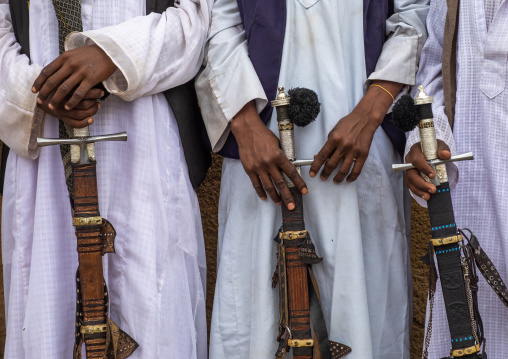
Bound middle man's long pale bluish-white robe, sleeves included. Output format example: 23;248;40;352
197;0;427;359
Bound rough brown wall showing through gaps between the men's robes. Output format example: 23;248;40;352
0;153;430;359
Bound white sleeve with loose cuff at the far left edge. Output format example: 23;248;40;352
0;0;44;159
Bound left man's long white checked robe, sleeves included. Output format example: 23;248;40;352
0;0;212;359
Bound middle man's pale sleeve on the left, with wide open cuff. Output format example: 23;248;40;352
195;0;268;152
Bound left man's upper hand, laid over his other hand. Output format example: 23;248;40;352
32;45;117;110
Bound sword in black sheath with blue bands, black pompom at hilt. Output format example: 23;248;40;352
392;86;508;359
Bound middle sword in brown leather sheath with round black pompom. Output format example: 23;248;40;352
272;87;351;359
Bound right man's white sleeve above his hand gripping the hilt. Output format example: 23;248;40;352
404;1;459;207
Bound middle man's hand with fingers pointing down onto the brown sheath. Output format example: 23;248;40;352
231;102;307;210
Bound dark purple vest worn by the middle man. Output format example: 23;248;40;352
219;0;405;158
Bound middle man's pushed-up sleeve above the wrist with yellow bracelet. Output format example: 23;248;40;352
369;0;429;86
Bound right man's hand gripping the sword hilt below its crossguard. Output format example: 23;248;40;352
406;140;452;201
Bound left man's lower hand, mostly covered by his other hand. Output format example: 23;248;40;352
37;89;104;128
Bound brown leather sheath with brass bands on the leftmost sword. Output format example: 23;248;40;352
72;163;107;358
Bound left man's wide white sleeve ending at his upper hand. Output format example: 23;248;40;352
66;0;213;101
